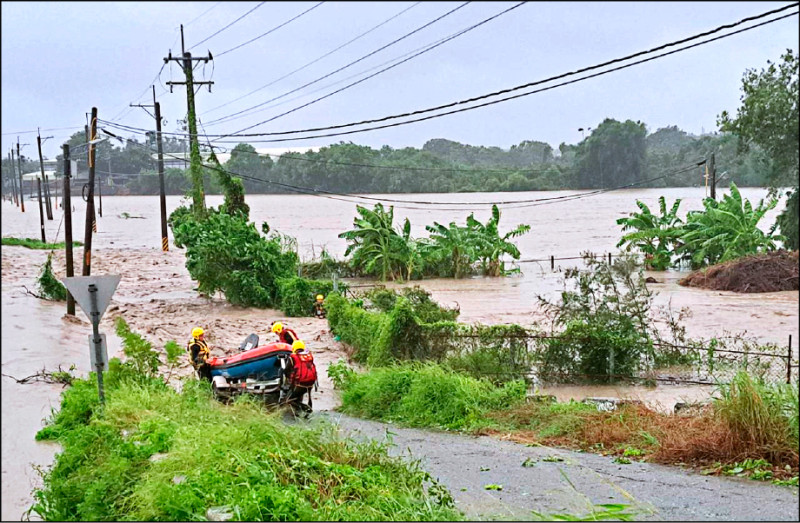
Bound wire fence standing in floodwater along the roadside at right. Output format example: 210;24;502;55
440;327;800;385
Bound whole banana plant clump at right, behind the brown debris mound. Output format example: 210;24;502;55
617;183;786;270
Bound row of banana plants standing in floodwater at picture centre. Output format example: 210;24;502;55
339;203;530;281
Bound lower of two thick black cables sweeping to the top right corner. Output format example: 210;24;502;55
208;7;798;143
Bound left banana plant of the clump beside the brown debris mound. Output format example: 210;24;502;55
617;196;682;271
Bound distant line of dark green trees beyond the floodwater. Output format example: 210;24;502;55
3;119;773;194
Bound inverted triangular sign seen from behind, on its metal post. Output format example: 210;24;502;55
61;274;120;403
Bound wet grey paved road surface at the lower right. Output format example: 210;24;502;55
320;412;800;521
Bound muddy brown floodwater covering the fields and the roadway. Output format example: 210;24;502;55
0;188;798;520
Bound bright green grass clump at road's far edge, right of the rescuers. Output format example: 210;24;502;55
342;363;526;429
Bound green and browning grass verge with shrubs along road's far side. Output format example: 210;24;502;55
328;290;798;485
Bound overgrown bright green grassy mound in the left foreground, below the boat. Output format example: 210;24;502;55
32;370;462;521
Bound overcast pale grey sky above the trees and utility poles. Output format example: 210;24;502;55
2;2;798;157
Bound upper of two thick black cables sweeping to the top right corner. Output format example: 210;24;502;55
211;2;800;137
